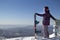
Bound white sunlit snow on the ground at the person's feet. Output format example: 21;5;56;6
0;33;60;40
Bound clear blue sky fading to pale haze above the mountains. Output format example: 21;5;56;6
0;0;60;25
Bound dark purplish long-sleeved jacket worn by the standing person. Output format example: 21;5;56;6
37;13;56;25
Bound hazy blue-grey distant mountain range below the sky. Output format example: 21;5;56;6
0;25;53;38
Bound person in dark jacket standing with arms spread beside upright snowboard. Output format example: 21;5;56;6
35;6;56;38
